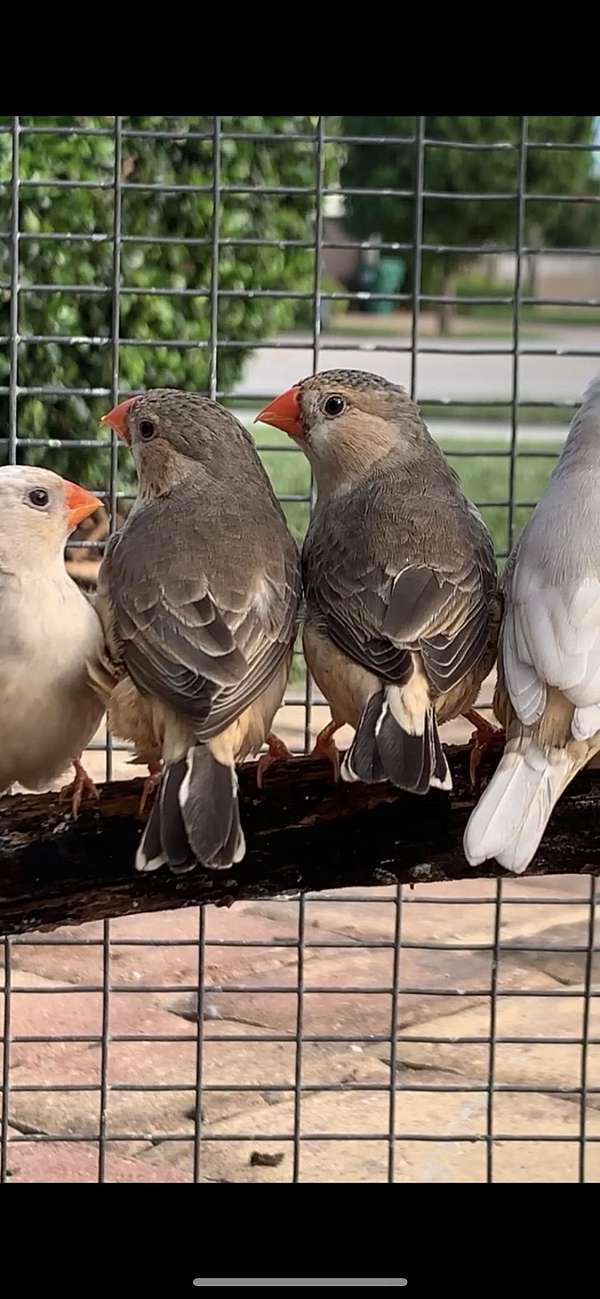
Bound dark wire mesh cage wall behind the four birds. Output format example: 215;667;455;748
0;117;600;1182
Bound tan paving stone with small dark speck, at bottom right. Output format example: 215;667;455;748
142;1070;600;1182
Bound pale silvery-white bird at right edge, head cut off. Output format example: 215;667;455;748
465;375;600;874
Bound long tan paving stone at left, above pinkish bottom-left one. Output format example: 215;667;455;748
9;1025;390;1139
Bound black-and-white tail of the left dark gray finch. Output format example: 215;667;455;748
135;744;245;872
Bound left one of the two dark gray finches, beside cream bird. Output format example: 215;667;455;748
97;390;300;870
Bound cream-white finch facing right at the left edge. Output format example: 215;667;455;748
0;465;104;816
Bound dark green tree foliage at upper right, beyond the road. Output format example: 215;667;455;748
342;116;599;324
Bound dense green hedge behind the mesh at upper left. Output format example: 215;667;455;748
0;117;335;485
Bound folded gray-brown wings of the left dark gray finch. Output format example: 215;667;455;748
103;496;299;739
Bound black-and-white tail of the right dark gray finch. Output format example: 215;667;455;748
342;683;452;794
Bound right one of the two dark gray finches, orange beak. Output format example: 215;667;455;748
257;370;499;794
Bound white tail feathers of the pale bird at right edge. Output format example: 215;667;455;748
464;738;579;876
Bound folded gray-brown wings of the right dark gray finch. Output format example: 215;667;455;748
305;491;496;694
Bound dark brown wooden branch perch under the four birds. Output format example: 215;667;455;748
0;748;600;934
